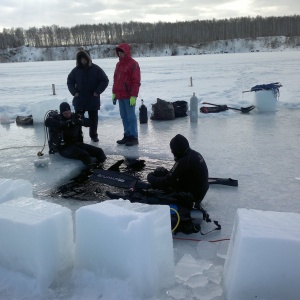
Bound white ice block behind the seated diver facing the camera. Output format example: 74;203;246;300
30;98;67;123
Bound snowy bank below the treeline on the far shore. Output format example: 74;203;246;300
0;36;300;62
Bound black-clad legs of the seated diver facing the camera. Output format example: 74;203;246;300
59;143;106;165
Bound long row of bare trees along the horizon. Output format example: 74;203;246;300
0;15;300;49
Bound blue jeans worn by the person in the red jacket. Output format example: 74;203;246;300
118;99;138;138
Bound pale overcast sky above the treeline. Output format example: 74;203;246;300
0;0;300;31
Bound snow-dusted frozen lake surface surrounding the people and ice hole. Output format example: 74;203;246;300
0;51;300;300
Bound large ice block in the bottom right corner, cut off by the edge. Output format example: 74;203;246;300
224;209;300;300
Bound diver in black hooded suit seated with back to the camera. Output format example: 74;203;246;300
147;134;209;208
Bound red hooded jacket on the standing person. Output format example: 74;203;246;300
112;43;141;99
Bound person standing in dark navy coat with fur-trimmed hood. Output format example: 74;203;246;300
67;50;109;142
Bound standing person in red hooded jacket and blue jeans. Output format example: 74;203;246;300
112;43;141;146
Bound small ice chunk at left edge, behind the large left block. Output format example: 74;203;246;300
0;178;32;203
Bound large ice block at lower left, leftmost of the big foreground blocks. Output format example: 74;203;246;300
0;197;74;288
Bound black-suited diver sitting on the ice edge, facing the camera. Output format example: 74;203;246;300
45;102;106;166
